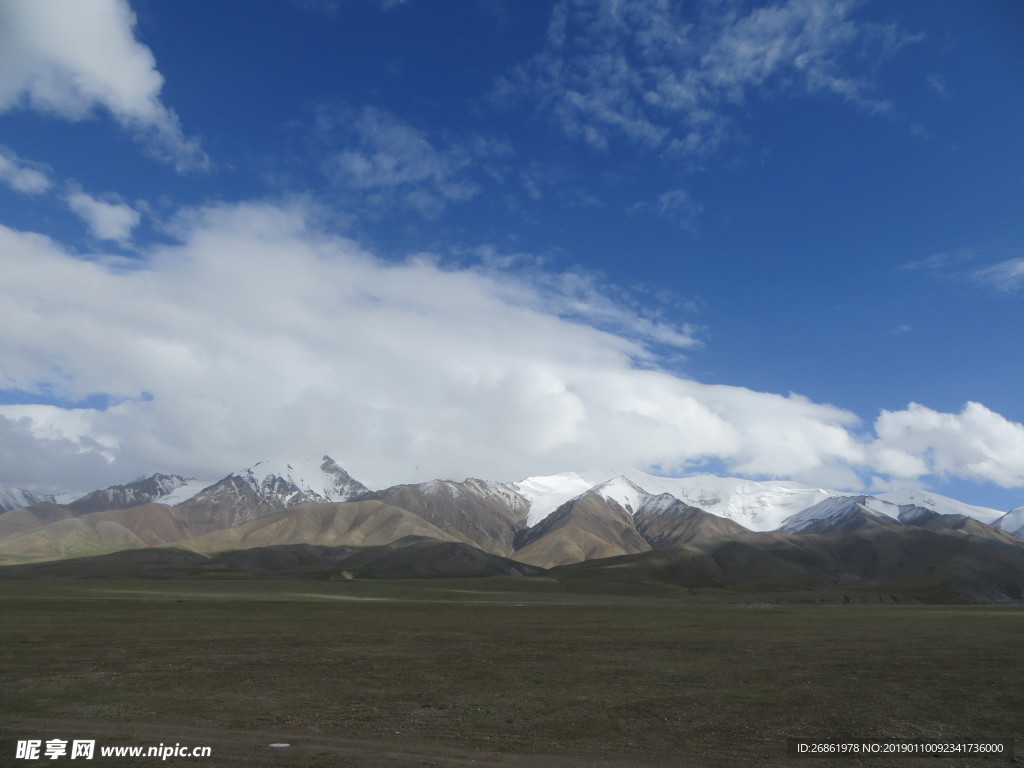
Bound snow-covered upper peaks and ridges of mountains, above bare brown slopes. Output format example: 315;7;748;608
0;456;1011;540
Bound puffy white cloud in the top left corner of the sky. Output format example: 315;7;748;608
0;0;208;169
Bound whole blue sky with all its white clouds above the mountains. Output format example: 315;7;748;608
0;0;1024;509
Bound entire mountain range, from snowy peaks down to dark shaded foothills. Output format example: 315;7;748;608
0;456;1024;602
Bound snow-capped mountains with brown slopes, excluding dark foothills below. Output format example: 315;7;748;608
0;456;1024;567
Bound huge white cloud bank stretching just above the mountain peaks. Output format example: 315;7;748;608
0;204;1024;495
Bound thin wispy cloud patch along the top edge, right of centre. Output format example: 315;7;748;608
498;0;913;156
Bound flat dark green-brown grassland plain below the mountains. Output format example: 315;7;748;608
0;579;1024;768
